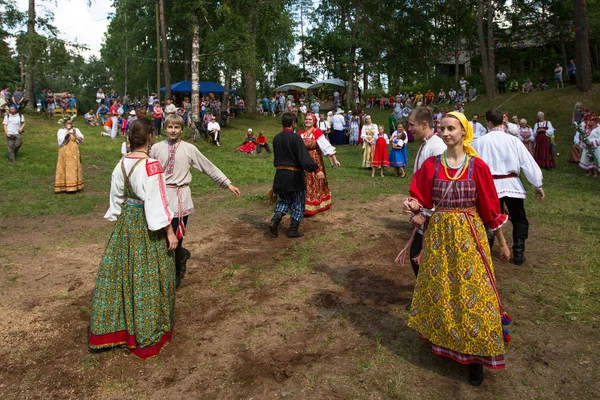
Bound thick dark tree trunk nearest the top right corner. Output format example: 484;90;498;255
574;0;592;92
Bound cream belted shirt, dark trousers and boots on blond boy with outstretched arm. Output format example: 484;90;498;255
150;139;231;286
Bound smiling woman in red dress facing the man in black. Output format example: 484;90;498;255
298;114;340;216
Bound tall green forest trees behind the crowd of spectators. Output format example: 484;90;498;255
0;0;600;115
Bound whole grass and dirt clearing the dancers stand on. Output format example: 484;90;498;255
0;86;600;399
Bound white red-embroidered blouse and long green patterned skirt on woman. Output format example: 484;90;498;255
89;157;175;358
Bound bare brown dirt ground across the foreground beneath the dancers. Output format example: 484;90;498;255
0;187;600;399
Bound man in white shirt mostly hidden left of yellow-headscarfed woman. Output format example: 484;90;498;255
396;107;446;310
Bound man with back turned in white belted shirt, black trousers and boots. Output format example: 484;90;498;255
474;110;546;265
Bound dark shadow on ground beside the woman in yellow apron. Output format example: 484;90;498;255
311;264;466;381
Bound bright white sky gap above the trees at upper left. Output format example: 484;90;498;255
16;0;114;58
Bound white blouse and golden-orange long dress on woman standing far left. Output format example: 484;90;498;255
54;128;85;193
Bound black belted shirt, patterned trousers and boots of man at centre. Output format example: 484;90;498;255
269;128;322;237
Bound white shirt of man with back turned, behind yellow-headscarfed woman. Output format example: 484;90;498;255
473;131;543;199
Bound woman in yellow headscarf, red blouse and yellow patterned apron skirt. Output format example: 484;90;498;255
401;112;510;386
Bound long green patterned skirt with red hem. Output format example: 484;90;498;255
89;200;175;358
